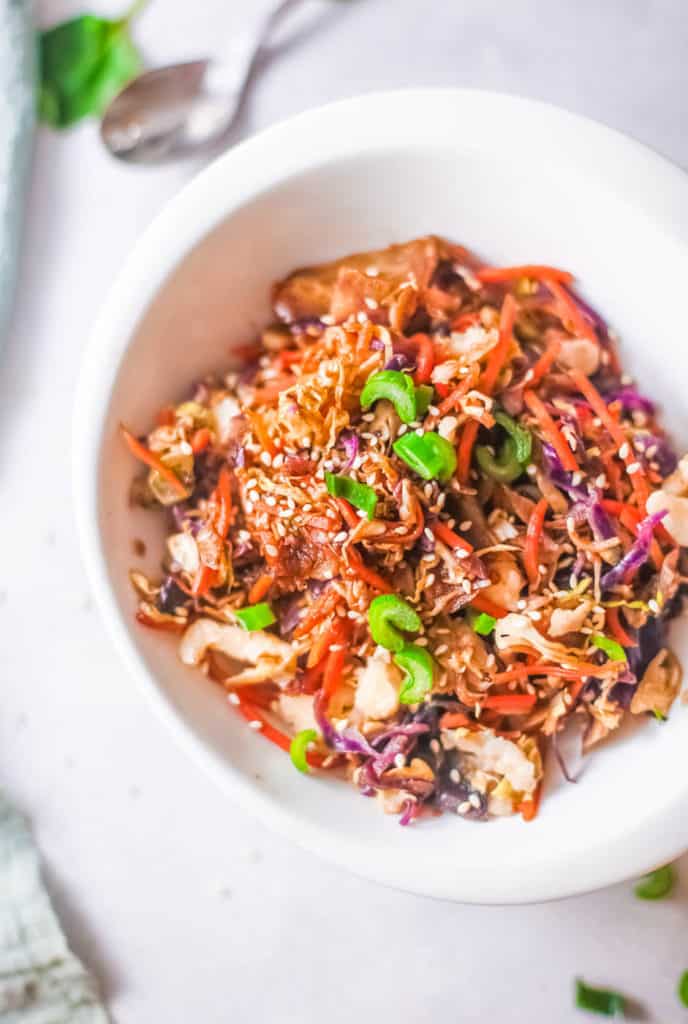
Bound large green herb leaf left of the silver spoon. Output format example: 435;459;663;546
38;11;142;128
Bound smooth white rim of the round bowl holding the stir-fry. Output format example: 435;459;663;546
72;88;688;904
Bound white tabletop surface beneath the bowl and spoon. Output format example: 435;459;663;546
0;0;688;1024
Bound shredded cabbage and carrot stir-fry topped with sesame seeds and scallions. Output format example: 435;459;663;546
123;237;688;824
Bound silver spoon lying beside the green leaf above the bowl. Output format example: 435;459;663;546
100;0;299;164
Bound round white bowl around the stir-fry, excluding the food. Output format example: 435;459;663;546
75;90;688;903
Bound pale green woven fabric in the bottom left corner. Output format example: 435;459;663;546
0;793;108;1024
